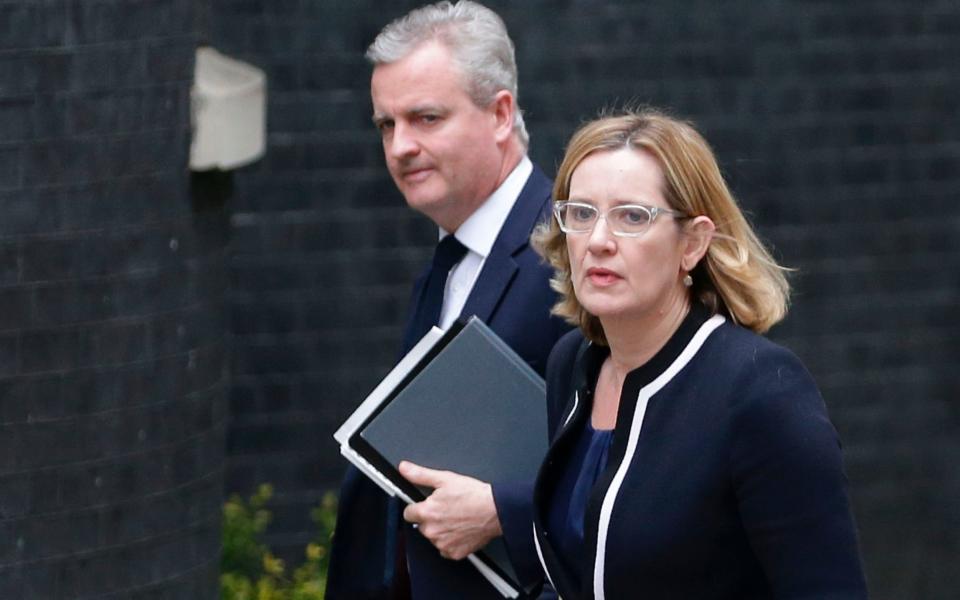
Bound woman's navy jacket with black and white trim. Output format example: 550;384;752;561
534;305;867;600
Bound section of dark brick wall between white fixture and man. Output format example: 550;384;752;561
209;1;431;559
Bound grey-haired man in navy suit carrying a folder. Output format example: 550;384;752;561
327;0;567;600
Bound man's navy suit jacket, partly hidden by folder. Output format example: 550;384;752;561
326;166;569;600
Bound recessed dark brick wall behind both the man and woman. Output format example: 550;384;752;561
210;0;960;599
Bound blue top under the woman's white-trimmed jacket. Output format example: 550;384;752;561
547;418;613;584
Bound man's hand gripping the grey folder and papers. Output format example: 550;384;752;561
400;461;503;560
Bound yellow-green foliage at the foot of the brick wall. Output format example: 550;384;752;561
220;484;337;600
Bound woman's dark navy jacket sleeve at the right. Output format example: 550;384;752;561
729;347;867;600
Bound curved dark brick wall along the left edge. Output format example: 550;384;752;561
0;0;228;600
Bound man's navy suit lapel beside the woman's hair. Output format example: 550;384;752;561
460;165;551;323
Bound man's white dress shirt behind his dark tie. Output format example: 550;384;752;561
439;156;533;330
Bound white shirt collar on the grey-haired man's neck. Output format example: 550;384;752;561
440;156;533;258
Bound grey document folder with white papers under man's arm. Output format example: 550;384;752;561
334;317;547;597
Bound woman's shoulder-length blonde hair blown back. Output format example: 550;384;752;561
532;108;790;344
